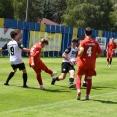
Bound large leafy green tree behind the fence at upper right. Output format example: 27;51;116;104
62;0;113;30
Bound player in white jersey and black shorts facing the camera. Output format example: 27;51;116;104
51;38;78;88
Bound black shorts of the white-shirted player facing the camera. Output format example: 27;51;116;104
61;62;75;73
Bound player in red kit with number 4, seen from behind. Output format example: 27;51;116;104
76;27;102;100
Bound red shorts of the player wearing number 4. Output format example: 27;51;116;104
77;67;96;76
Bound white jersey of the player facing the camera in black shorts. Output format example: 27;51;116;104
63;46;78;62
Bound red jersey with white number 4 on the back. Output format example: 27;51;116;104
78;38;102;69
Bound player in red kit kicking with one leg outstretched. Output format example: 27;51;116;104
29;38;57;90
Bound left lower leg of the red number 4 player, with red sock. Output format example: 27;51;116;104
76;75;82;100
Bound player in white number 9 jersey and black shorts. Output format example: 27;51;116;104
0;31;30;88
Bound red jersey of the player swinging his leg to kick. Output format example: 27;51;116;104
29;43;42;65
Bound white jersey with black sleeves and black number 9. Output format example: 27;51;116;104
2;40;23;65
